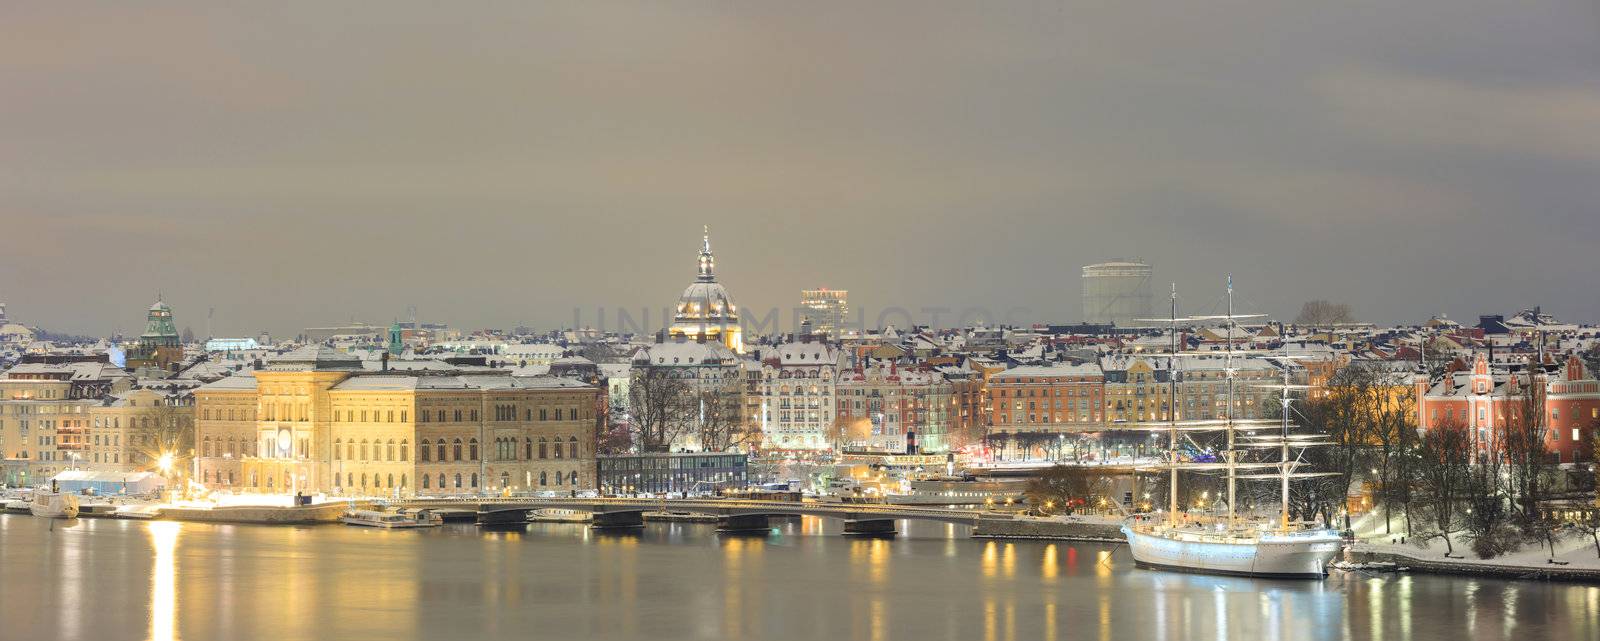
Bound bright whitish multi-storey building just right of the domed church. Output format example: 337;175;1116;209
760;337;840;451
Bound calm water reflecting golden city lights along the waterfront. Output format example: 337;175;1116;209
0;515;1600;641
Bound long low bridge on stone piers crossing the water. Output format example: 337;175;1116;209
408;497;1011;535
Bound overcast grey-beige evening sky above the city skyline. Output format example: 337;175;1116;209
0;0;1600;336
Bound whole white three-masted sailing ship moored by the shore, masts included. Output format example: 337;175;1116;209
1122;277;1342;579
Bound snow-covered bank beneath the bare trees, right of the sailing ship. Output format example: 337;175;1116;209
1350;510;1600;571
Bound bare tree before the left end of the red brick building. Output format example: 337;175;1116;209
1416;420;1472;556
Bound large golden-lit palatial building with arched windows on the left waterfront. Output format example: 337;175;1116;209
195;345;602;496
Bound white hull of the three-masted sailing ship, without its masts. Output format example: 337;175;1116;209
1122;526;1342;579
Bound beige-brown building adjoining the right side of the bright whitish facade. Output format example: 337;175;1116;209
835;361;955;454
